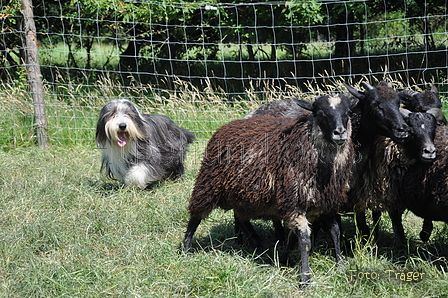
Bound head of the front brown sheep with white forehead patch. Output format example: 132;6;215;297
294;95;358;145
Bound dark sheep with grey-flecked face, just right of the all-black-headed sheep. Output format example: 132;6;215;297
358;109;436;245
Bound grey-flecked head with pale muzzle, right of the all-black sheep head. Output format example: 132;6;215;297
400;109;437;162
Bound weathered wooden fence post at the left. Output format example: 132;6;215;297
22;0;48;148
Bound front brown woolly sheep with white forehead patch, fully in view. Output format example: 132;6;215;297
183;95;356;283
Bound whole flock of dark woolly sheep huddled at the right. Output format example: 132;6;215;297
183;82;448;283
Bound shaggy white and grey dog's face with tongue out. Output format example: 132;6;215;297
96;99;144;147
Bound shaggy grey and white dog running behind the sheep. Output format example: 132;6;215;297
96;99;195;189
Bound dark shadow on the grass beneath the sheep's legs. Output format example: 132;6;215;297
183;217;448;272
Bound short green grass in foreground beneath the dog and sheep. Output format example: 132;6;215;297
0;143;448;297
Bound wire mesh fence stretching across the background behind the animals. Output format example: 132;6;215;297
0;0;448;148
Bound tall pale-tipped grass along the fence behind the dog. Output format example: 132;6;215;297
0;74;309;150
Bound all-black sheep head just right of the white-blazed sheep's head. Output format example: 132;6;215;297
344;82;409;143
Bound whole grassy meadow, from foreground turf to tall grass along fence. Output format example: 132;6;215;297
0;76;448;297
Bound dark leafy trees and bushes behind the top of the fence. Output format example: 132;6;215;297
0;0;445;88
